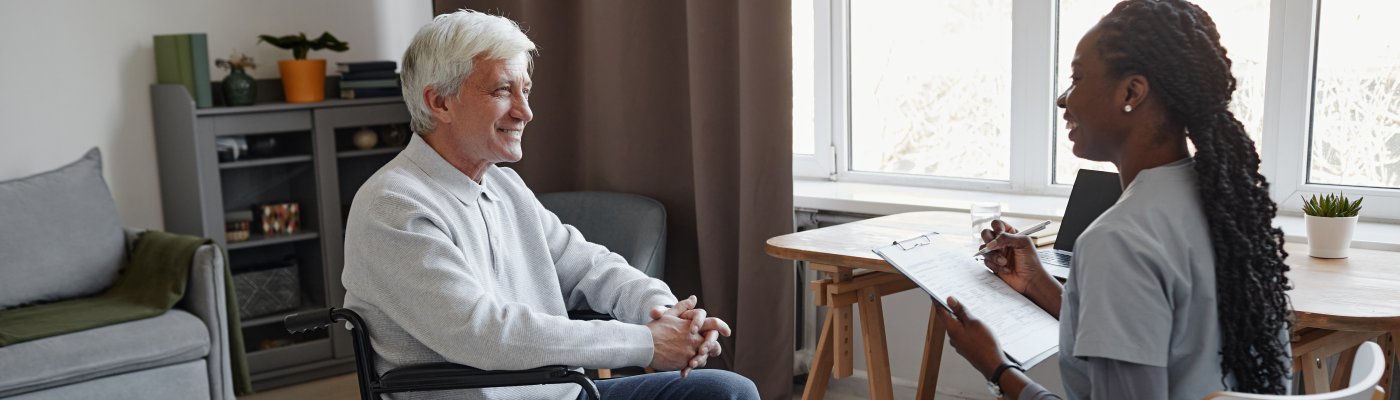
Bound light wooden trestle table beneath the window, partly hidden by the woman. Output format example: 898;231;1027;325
767;211;1400;399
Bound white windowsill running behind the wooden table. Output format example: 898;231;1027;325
792;178;1400;252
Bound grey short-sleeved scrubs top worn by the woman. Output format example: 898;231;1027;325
1022;158;1287;400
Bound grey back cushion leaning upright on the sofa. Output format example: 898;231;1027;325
0;147;125;309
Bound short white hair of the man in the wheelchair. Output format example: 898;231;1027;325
402;10;535;134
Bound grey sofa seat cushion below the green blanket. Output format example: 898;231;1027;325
0;309;209;397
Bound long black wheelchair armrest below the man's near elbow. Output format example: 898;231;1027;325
379;362;598;399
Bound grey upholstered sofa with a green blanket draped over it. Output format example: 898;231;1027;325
0;148;234;399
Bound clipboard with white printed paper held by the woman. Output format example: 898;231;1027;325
872;232;1060;368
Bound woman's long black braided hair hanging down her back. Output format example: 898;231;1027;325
1098;0;1291;394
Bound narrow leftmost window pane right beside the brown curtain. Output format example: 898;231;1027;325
792;0;816;154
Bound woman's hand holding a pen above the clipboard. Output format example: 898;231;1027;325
981;220;1064;319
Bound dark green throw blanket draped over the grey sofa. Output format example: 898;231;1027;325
0;231;252;394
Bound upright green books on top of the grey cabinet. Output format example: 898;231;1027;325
155;34;214;108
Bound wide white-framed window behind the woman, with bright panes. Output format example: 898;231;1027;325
792;0;1400;220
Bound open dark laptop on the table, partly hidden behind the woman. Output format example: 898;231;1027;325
1037;169;1123;280
